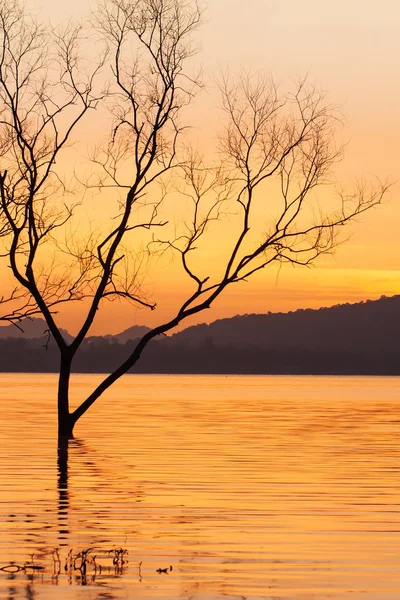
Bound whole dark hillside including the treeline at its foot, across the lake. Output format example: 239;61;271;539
0;296;400;375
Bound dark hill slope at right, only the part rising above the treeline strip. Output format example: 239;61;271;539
171;295;400;351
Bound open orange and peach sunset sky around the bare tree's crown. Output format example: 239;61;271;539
3;0;400;333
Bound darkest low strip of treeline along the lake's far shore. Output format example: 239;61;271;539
0;339;400;375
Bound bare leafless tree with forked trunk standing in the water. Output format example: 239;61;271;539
0;0;386;436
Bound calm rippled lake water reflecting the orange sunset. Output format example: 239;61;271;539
0;374;400;600
